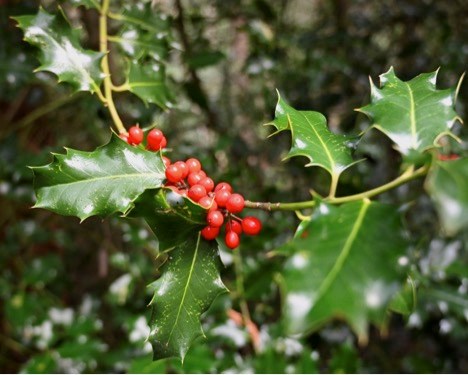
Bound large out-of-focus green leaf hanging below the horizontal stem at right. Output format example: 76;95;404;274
278;200;406;341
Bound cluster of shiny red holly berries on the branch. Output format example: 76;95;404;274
120;126;262;249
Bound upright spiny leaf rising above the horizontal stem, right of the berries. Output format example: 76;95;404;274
266;93;356;179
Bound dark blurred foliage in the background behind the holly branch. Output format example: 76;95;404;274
0;0;468;373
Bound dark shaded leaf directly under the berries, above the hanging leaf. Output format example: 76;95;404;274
135;188;207;251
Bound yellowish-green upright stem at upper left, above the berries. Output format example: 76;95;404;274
99;0;127;133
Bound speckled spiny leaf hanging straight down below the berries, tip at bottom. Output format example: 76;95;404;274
149;234;227;361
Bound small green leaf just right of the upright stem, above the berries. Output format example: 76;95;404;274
127;61;172;109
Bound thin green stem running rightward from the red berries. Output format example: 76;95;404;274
245;166;429;211
